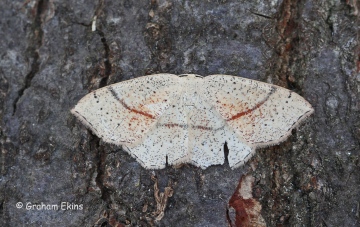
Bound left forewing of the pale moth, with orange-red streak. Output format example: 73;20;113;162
71;74;179;145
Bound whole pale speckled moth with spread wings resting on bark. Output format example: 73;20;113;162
71;74;313;169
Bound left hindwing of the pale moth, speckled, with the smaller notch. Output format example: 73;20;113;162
127;94;189;169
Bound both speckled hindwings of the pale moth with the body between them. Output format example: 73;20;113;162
127;80;254;169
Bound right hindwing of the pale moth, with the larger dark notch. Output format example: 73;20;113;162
187;91;254;169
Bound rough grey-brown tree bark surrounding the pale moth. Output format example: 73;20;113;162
0;0;360;226
